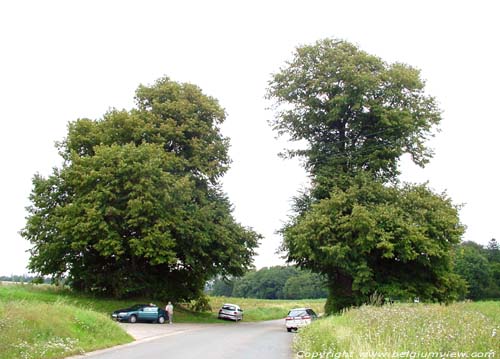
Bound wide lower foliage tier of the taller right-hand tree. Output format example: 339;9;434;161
283;178;463;312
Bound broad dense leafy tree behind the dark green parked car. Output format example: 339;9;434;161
22;78;259;300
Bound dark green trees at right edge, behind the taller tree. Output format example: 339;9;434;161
454;239;500;300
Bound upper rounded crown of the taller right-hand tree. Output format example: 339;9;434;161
268;39;441;186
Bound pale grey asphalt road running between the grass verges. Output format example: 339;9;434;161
72;320;294;359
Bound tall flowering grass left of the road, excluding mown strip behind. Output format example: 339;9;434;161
0;299;132;359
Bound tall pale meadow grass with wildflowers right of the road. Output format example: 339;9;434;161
294;302;500;358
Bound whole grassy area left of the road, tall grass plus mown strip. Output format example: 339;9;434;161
0;284;137;359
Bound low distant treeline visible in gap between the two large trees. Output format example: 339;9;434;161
208;266;327;299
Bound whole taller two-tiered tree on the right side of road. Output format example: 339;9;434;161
268;39;463;311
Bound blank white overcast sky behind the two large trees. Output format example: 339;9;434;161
0;0;500;275
